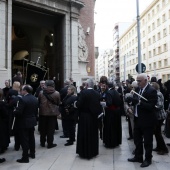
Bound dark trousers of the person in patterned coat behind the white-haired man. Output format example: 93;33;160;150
155;120;168;151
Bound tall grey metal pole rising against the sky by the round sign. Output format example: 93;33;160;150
136;0;142;74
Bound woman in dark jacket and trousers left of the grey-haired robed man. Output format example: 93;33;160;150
60;85;78;146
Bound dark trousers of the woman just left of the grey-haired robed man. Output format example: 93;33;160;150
65;119;76;142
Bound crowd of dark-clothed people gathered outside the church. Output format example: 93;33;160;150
0;73;170;167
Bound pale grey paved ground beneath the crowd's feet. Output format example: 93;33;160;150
0;117;170;170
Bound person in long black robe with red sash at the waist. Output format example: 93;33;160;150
103;83;122;148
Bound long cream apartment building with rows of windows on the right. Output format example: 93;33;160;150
119;0;170;82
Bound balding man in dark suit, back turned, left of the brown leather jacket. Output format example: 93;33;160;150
14;85;38;163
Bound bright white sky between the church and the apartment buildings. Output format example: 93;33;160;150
94;0;154;51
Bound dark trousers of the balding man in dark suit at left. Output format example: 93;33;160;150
19;127;35;159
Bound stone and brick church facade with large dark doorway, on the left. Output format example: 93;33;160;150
0;0;95;88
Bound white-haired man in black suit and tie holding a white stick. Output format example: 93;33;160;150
128;73;157;167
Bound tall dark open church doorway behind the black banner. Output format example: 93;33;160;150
12;3;65;89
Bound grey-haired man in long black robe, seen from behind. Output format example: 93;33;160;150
74;79;102;159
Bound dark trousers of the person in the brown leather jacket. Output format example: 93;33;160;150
39;116;56;145
